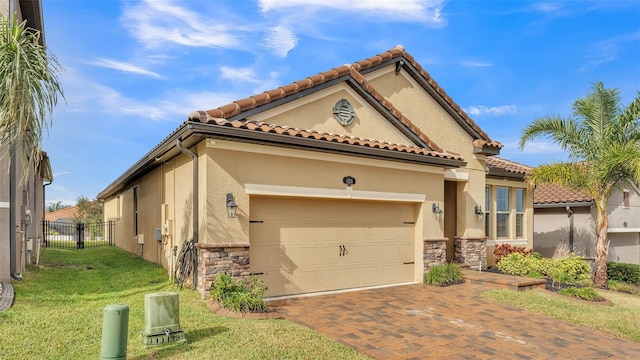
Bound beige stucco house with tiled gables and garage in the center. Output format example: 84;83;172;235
97;46;533;296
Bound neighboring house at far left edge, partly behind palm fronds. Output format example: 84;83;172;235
0;0;53;282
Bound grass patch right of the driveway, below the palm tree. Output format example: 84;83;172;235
481;290;640;343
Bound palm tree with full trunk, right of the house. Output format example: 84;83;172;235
520;82;640;287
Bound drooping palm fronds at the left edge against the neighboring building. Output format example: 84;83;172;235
0;18;64;180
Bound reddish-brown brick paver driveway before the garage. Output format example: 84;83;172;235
270;284;640;359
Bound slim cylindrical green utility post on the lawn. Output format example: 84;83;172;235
100;304;129;360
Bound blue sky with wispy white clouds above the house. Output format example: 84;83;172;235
43;0;640;205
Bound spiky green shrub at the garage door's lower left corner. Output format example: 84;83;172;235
211;273;267;312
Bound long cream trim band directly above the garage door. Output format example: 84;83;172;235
244;184;427;203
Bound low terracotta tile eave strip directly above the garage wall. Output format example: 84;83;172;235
189;111;462;161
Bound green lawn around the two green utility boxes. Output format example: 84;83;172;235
0;247;367;360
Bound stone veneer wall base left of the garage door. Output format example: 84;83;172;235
196;243;249;299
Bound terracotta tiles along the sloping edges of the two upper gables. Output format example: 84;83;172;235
189;46;502;152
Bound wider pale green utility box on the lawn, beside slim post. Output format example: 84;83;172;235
140;292;187;347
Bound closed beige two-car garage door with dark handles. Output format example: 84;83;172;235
249;197;416;296
